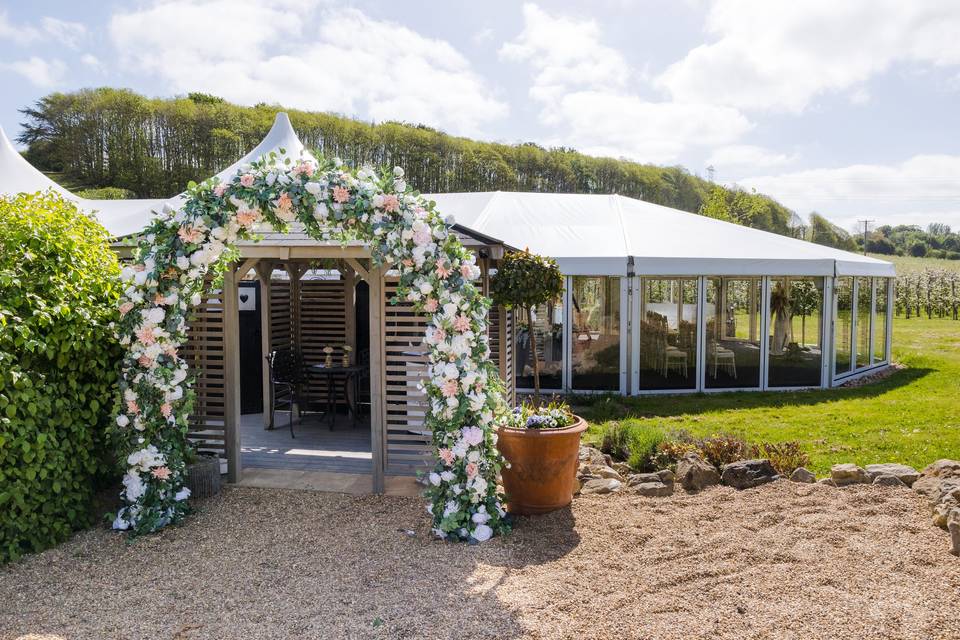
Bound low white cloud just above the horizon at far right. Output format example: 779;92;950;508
740;155;960;228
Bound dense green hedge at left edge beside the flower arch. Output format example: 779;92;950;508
0;193;120;562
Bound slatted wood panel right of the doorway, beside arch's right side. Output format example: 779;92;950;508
380;276;433;473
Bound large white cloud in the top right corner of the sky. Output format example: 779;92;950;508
658;0;960;112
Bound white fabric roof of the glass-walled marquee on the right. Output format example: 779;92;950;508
428;191;895;276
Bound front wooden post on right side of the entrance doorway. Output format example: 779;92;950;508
368;267;386;493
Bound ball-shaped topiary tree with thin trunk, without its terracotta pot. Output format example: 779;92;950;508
490;251;563;402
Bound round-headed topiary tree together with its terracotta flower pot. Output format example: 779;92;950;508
491;251;587;514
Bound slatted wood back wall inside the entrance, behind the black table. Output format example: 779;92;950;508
297;276;356;406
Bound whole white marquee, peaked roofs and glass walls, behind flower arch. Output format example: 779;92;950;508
0;113;895;393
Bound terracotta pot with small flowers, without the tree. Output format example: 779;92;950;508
497;402;587;515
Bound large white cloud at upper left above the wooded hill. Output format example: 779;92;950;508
110;0;507;135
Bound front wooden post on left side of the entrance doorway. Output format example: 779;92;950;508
221;264;243;482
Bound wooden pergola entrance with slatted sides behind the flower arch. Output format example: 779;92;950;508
176;227;515;493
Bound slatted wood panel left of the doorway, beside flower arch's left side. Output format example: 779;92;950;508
181;284;226;457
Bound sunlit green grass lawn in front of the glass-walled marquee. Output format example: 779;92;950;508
575;318;960;474
